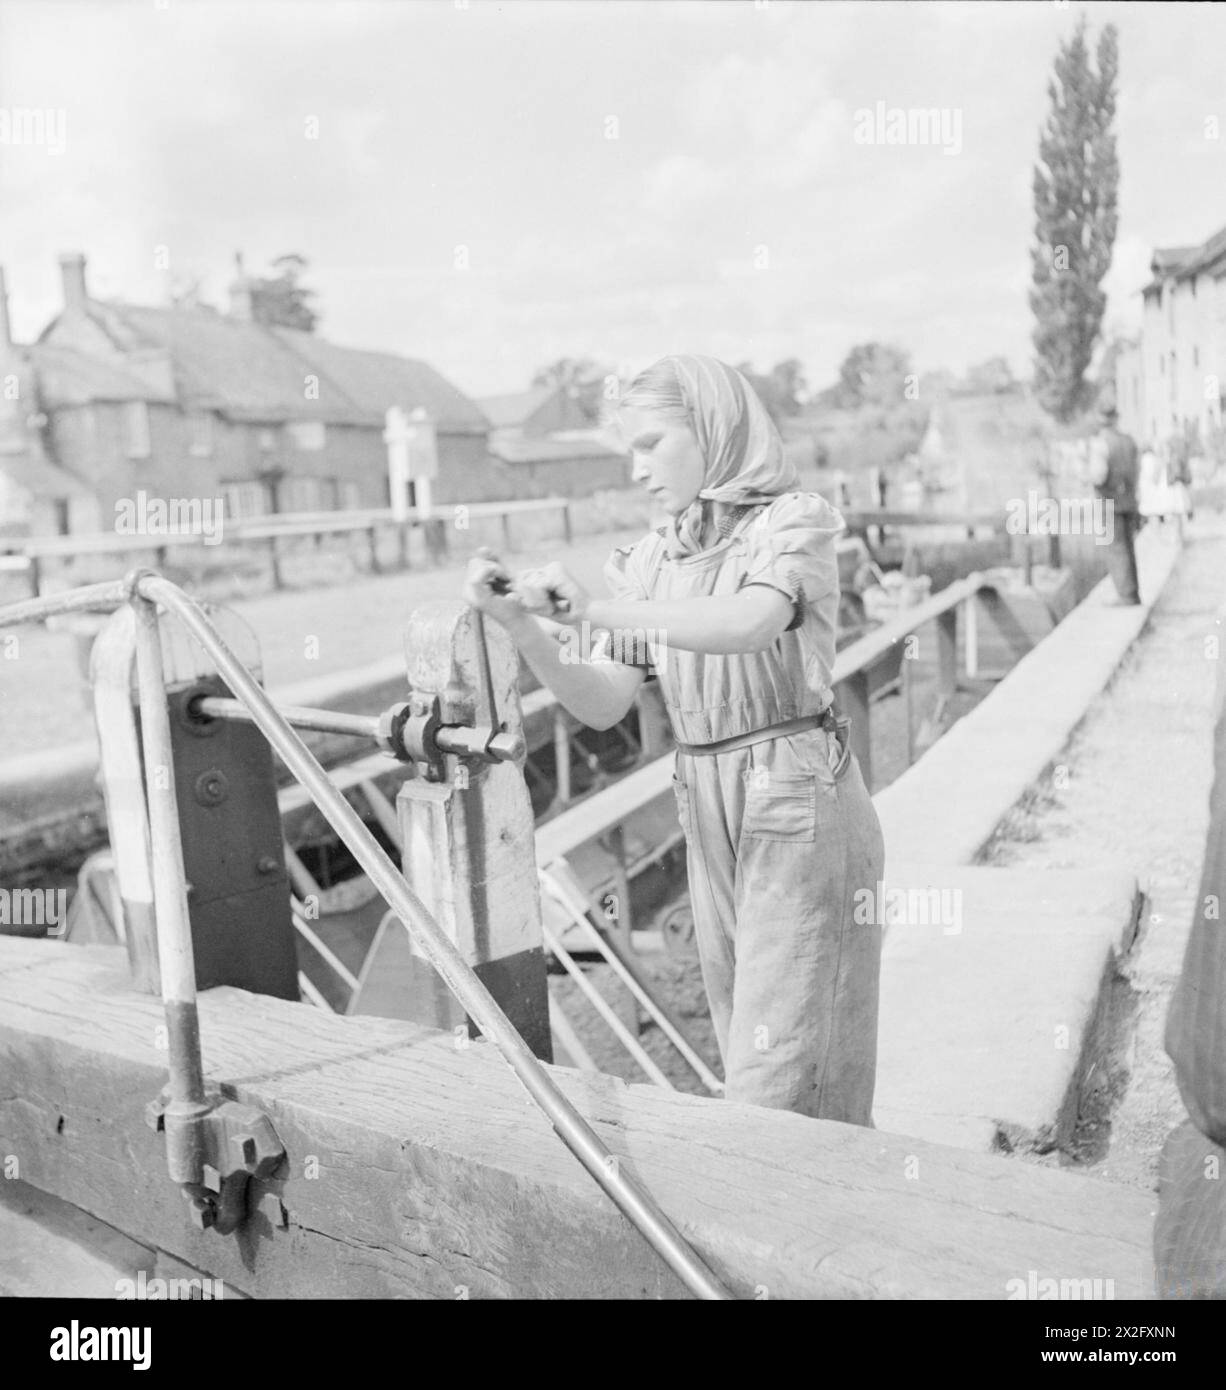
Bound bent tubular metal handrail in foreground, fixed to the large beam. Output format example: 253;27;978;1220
0;570;731;1300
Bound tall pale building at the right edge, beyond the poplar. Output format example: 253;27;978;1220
1115;227;1226;453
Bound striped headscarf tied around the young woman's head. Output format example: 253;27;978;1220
653;353;801;559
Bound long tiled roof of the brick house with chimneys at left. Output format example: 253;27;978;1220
32;300;488;434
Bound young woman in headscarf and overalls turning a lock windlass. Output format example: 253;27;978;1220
466;356;883;1125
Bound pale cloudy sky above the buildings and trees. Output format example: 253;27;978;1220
0;0;1226;395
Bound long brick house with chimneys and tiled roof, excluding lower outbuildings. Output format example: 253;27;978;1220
0;254;505;530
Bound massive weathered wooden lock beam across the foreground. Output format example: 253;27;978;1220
0;938;1151;1298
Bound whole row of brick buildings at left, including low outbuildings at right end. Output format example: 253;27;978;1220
0;253;630;537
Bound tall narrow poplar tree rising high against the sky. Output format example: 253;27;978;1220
1030;15;1119;423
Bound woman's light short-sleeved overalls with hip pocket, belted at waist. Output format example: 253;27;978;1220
606;493;884;1125
